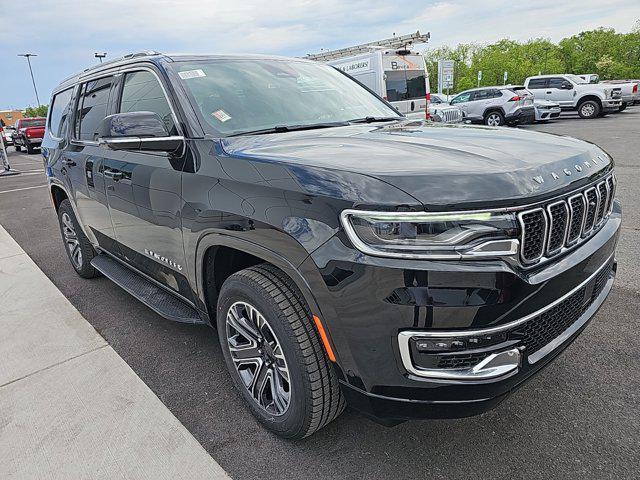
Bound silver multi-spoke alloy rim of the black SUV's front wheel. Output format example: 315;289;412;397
226;302;291;415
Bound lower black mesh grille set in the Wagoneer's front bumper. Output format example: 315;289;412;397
509;263;611;355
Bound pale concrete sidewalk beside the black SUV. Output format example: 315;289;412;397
0;226;229;480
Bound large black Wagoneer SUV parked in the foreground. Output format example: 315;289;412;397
43;53;621;438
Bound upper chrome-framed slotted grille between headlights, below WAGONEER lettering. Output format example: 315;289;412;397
518;174;616;265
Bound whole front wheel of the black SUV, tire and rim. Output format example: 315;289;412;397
216;264;345;439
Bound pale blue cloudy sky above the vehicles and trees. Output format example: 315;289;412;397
0;0;640;109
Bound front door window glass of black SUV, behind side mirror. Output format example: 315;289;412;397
120;71;177;135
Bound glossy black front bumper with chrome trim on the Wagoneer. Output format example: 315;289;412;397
307;203;621;422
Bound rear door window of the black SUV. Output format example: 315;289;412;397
76;77;112;140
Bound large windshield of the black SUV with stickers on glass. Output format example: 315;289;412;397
173;59;402;135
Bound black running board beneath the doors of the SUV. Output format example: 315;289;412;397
91;254;204;323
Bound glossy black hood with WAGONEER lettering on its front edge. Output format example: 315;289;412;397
222;122;612;209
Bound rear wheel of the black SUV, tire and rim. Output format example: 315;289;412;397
58;199;99;278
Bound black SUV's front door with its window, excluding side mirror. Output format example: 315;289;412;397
102;66;189;296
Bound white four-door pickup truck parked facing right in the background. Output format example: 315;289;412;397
524;74;622;118
